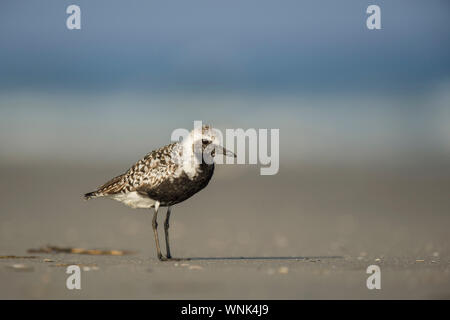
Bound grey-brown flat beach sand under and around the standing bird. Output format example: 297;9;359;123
0;165;450;299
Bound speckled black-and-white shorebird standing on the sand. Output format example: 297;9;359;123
84;125;236;261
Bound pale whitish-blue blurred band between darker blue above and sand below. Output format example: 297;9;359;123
0;83;450;168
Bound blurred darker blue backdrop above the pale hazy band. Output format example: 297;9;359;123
0;0;450;91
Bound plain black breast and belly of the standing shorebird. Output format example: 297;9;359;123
145;164;214;206
